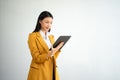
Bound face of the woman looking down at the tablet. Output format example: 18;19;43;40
40;17;53;33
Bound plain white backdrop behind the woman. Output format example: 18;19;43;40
0;0;120;80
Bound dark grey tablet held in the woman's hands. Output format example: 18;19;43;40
50;36;71;50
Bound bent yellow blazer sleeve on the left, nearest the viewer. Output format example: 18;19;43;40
28;33;47;63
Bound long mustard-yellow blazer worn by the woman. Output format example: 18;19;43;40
27;32;60;80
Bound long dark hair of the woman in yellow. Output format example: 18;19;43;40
33;11;53;32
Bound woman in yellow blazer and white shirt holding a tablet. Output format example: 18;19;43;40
27;11;64;80
